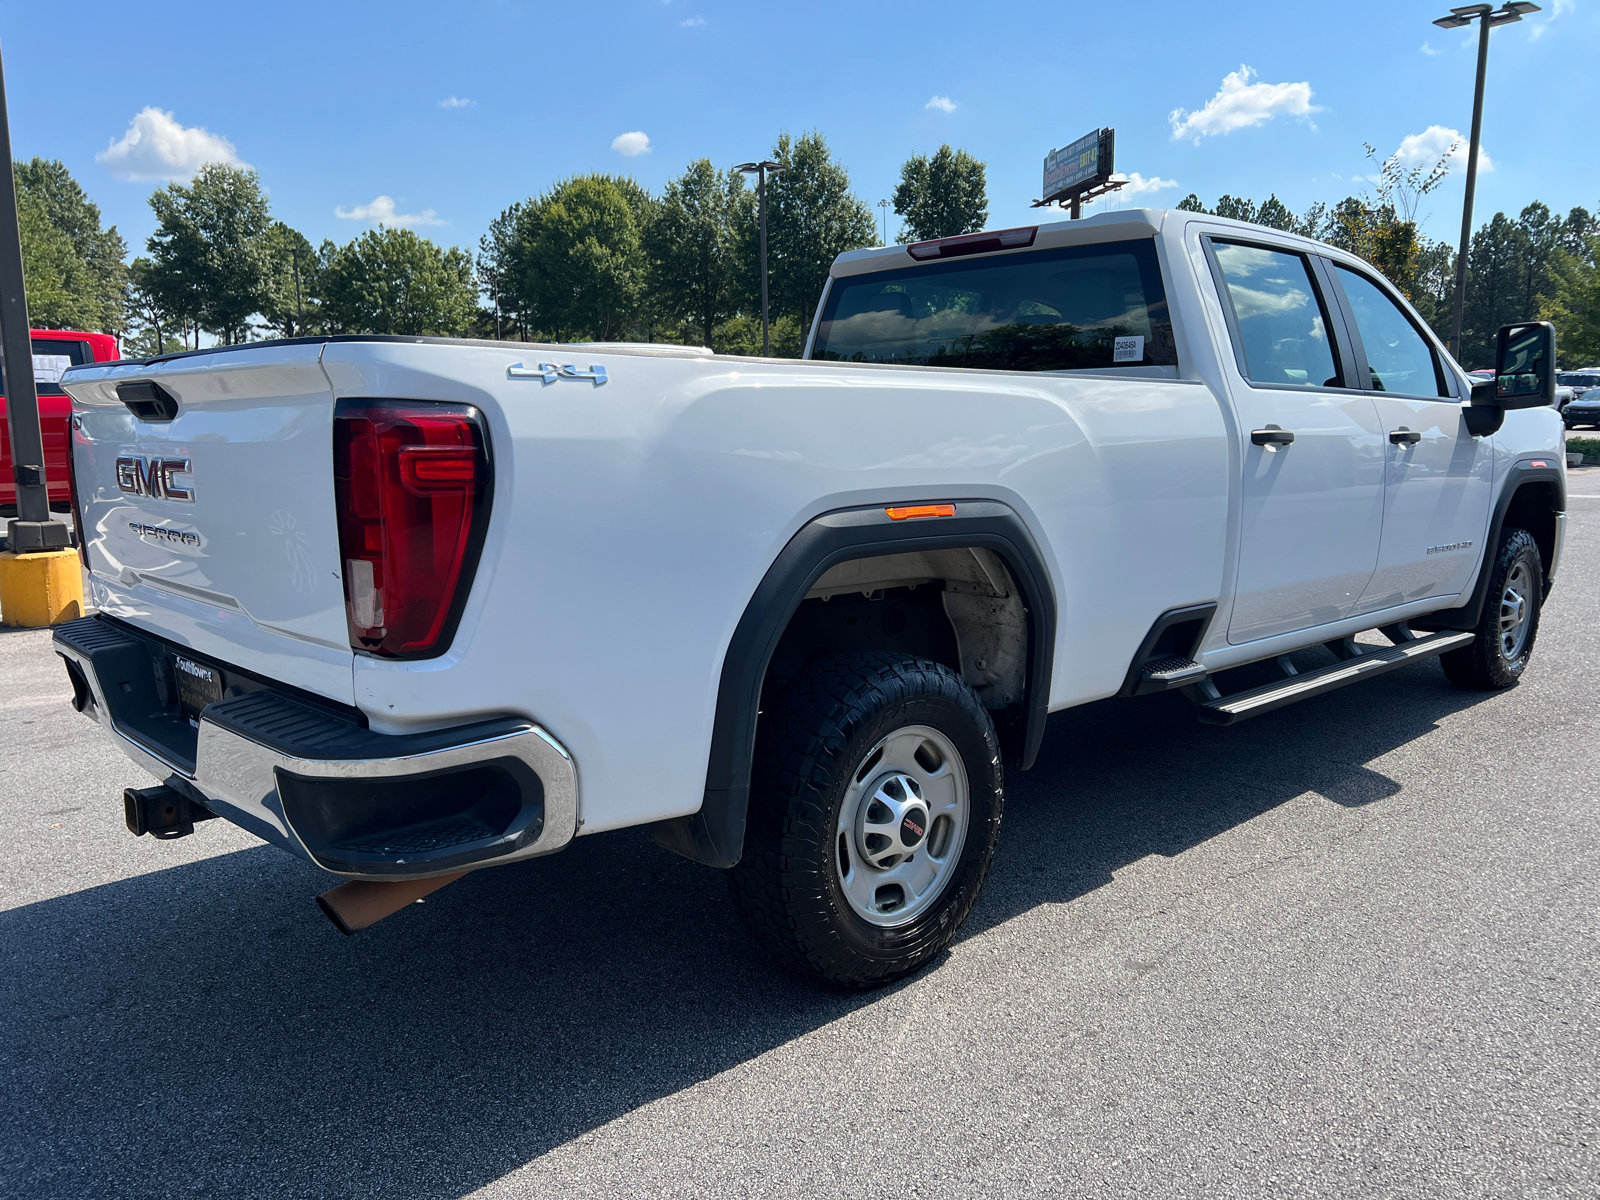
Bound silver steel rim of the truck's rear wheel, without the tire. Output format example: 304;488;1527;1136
834;725;971;928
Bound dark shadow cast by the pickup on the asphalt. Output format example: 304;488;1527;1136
0;669;1477;1200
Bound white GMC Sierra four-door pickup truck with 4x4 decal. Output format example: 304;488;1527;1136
56;211;1566;986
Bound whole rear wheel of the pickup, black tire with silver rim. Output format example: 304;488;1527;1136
728;651;1005;987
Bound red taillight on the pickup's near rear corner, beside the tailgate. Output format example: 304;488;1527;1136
333;400;490;658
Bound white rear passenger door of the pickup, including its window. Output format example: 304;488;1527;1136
1211;237;1386;645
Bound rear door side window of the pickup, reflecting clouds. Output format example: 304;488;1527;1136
1211;242;1342;387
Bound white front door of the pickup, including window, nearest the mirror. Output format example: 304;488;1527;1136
1333;266;1493;613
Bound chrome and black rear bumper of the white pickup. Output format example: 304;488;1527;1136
54;616;578;880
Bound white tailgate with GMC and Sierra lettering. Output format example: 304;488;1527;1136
62;344;352;704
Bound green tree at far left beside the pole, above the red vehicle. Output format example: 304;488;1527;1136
14;157;128;331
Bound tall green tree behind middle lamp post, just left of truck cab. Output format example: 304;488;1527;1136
744;130;878;340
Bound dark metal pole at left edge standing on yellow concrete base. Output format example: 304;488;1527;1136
0;36;67;552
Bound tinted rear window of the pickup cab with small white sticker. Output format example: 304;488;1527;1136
811;238;1178;371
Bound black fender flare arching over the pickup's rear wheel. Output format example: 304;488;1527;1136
651;499;1056;867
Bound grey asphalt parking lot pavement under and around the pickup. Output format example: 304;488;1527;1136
0;483;1600;1200
